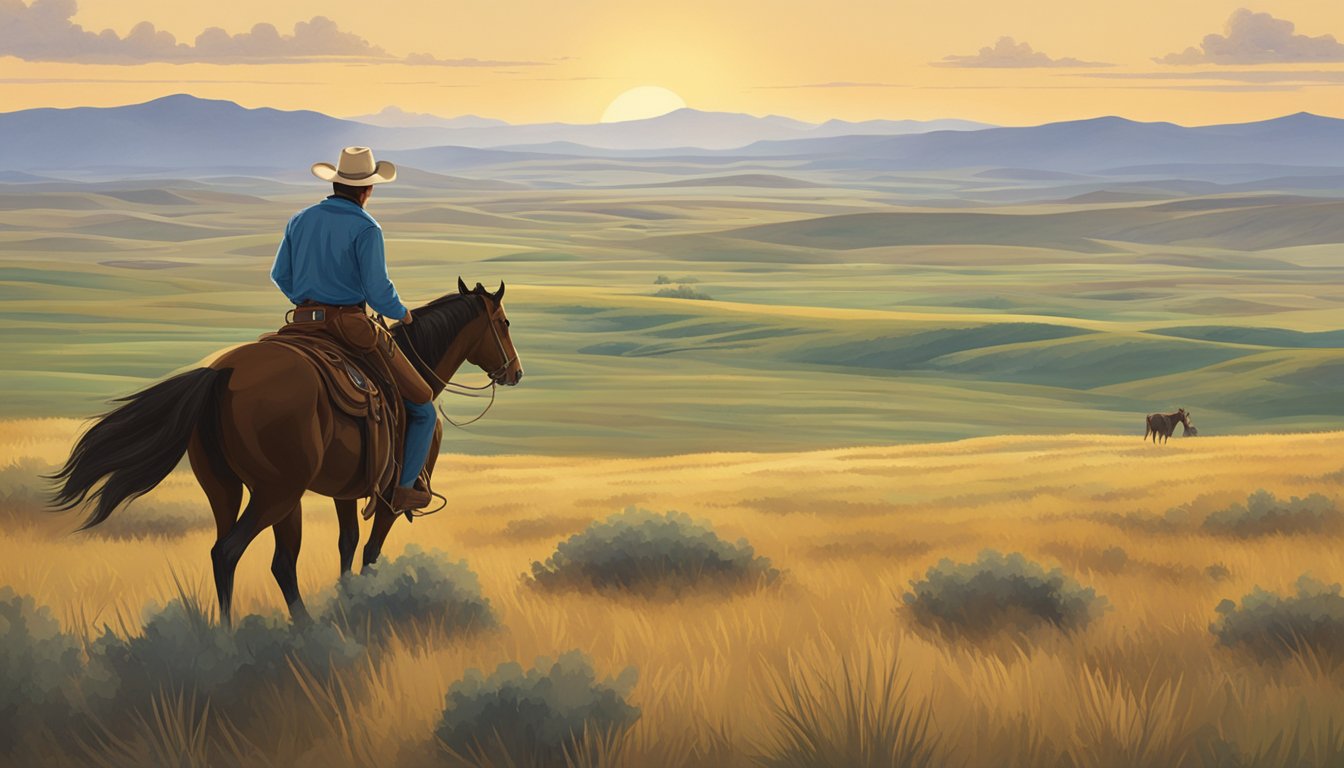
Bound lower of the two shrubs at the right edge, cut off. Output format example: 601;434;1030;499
1208;576;1344;660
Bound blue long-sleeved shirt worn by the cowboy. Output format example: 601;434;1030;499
270;195;406;320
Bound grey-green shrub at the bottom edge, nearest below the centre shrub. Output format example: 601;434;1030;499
435;651;640;765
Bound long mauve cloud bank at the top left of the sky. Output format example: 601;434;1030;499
0;0;548;66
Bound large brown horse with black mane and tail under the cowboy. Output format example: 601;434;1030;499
54;278;523;624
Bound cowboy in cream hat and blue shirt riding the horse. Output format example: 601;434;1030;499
270;147;438;511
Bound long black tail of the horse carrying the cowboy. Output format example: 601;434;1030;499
47;369;233;530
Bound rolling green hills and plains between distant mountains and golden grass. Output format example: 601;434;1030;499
0;160;1344;456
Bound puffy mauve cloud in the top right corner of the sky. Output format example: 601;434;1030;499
1153;8;1344;65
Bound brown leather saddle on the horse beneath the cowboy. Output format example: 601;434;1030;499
257;309;405;508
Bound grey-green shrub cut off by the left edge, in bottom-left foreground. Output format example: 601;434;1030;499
0;586;82;753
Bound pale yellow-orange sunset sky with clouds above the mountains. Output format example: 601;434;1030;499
0;0;1344;125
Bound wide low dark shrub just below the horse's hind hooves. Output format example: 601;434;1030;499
90;594;364;712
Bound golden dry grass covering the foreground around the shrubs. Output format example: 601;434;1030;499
0;420;1344;767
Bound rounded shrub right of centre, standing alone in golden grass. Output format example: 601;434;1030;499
903;550;1106;635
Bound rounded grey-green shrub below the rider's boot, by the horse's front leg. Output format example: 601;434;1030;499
324;545;495;639
